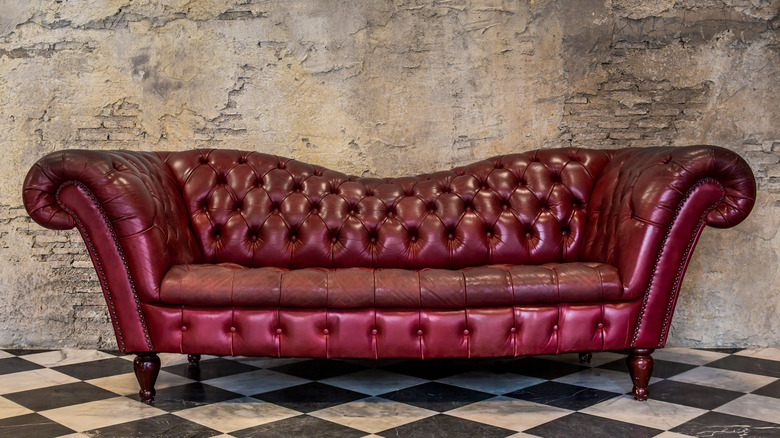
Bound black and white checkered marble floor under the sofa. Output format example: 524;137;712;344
0;348;780;438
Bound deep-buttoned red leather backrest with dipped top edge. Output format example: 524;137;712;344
161;148;611;269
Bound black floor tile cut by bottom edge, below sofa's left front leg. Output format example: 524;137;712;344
84;414;221;438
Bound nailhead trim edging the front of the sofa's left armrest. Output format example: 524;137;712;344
54;180;154;352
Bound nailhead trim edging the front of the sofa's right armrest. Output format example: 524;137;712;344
631;177;726;348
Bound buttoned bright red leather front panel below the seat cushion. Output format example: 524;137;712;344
143;300;641;359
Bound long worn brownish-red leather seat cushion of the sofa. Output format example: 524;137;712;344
160;263;635;308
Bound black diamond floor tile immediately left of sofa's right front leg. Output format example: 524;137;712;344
505;382;620;411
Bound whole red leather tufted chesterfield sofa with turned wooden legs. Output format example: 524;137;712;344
24;146;756;402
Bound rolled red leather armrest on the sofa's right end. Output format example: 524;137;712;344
580;146;756;348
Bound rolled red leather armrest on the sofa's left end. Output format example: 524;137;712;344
23;150;201;351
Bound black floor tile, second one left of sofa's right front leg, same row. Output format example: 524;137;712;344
379;382;495;412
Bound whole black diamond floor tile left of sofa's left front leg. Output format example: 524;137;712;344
3;382;117;411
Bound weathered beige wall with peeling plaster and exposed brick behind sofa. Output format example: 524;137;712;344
0;0;780;347
